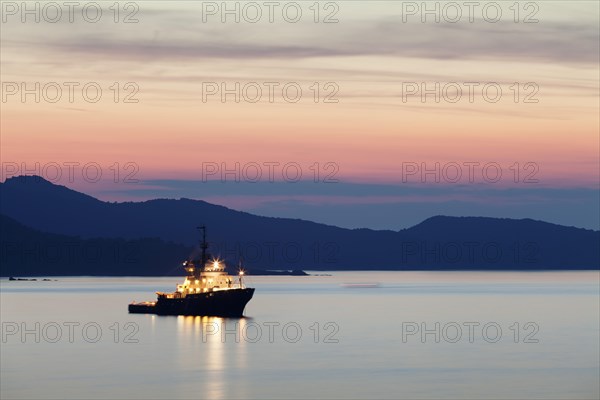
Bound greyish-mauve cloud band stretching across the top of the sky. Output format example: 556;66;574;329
3;9;599;63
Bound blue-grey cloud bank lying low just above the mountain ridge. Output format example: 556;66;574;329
88;180;600;230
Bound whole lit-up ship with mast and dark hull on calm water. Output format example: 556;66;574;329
129;226;254;318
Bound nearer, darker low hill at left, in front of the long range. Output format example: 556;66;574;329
0;215;191;276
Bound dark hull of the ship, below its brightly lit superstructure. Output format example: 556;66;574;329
129;288;254;317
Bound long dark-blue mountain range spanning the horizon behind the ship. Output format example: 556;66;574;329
0;176;600;275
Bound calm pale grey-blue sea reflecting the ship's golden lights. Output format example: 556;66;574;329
0;271;600;399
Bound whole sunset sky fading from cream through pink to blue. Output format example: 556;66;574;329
0;1;600;230
